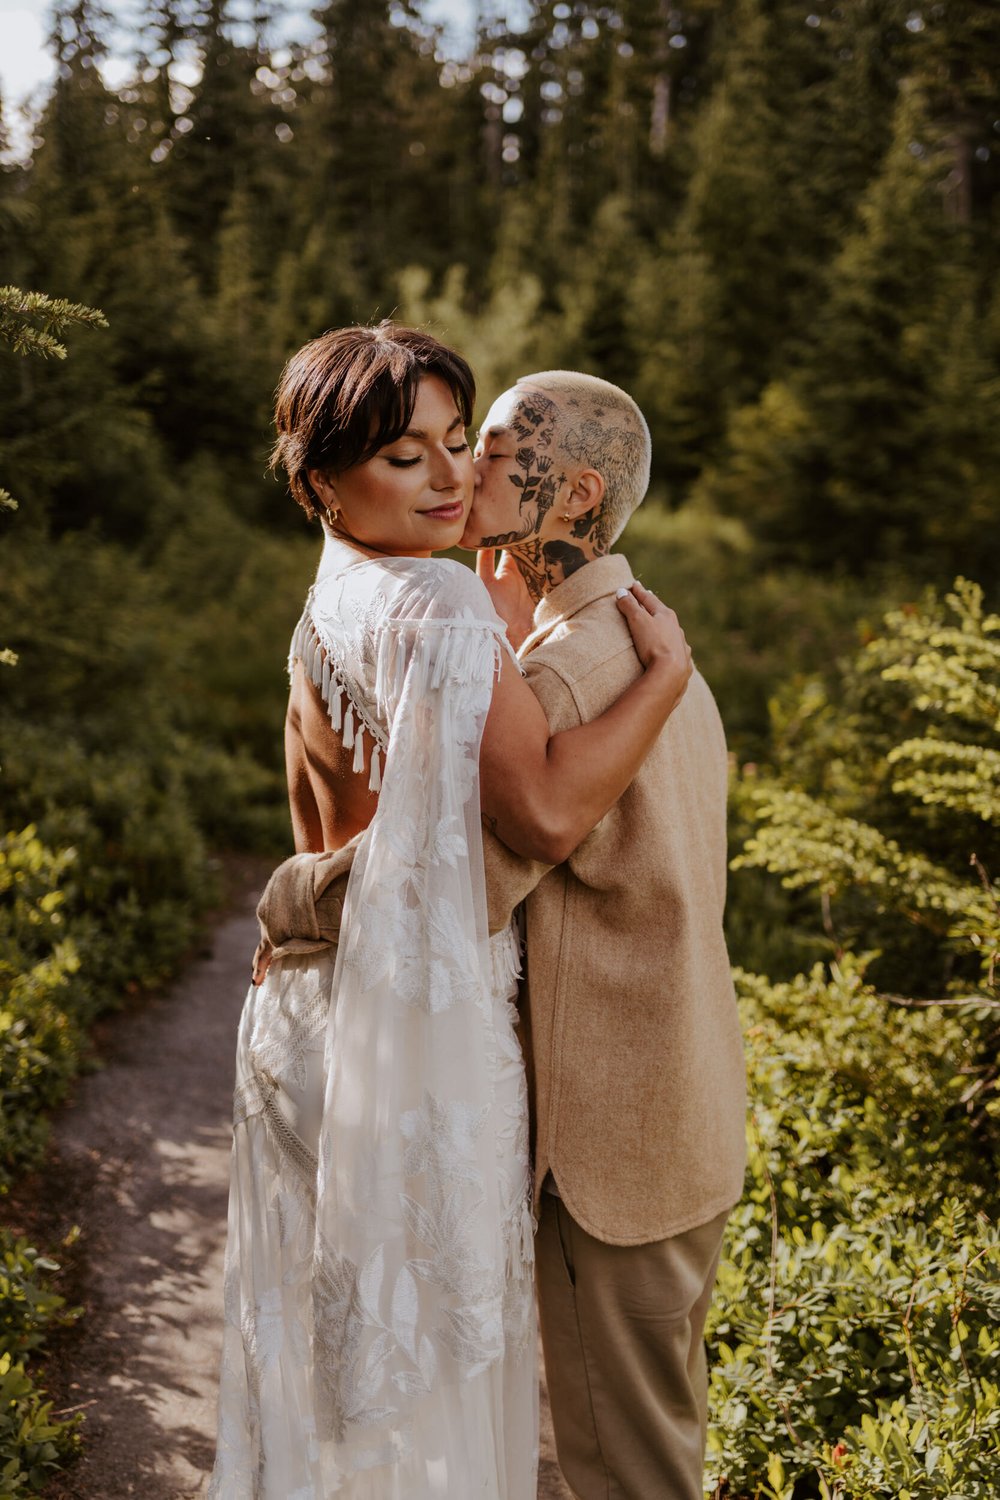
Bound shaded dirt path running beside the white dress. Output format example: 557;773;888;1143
12;890;571;1500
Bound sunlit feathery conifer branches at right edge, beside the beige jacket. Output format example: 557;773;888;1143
736;579;1000;1002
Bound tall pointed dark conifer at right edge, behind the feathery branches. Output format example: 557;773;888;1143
700;90;997;573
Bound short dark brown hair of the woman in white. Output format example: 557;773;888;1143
271;318;475;516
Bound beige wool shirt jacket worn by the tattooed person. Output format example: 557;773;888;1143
258;555;745;1245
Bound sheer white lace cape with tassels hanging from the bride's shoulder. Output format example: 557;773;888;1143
300;558;513;1473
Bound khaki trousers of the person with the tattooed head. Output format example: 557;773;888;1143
535;1191;729;1500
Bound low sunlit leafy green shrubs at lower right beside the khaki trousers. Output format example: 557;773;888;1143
709;960;1000;1500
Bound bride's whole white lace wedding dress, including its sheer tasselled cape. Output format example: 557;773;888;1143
208;549;538;1500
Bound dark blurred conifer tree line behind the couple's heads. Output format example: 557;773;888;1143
0;0;1000;567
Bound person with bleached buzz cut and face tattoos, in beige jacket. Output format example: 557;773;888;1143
259;371;745;1500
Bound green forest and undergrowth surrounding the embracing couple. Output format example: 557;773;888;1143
0;0;1000;1500
